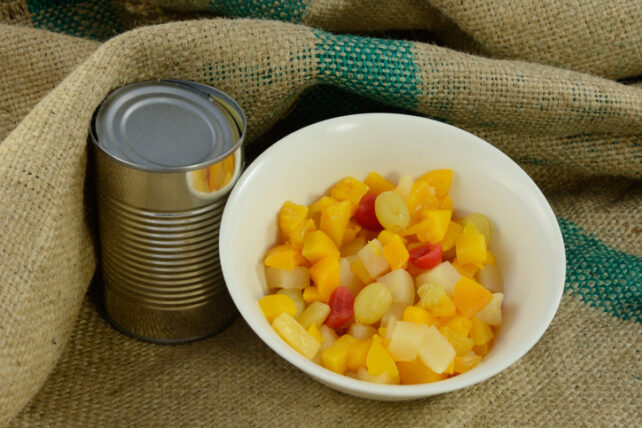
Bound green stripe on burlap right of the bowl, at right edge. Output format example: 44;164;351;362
558;218;642;322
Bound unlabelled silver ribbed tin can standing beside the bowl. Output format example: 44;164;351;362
91;80;246;343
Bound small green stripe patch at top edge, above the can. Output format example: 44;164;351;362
208;0;306;23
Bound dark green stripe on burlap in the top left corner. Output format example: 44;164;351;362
27;0;125;40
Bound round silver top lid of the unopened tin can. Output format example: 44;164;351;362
92;81;246;172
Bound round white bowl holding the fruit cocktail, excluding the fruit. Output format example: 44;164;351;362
219;113;566;400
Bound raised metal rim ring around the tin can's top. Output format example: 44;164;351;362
89;79;247;174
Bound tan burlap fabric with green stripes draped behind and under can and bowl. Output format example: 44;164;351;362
0;0;642;427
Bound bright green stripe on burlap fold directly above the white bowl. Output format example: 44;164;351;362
314;30;420;108
